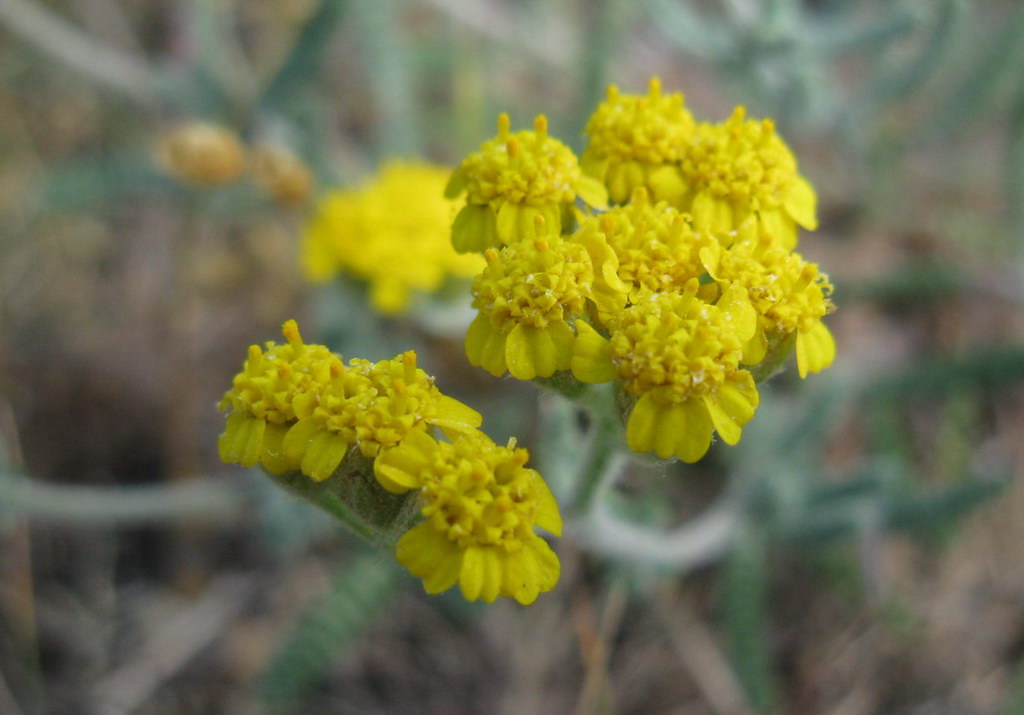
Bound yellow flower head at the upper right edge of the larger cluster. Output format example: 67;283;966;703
678;107;817;248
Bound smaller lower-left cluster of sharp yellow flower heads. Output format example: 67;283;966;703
218;321;561;604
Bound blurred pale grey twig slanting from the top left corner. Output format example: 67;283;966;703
0;0;156;104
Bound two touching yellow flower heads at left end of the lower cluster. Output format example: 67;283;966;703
218;321;482;481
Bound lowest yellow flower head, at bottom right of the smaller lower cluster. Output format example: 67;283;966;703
374;431;562;605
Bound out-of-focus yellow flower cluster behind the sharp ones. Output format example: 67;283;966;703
302;162;483;314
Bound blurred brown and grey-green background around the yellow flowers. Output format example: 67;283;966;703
0;0;1024;714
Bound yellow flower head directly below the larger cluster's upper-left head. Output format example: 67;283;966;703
466;228;594;380
